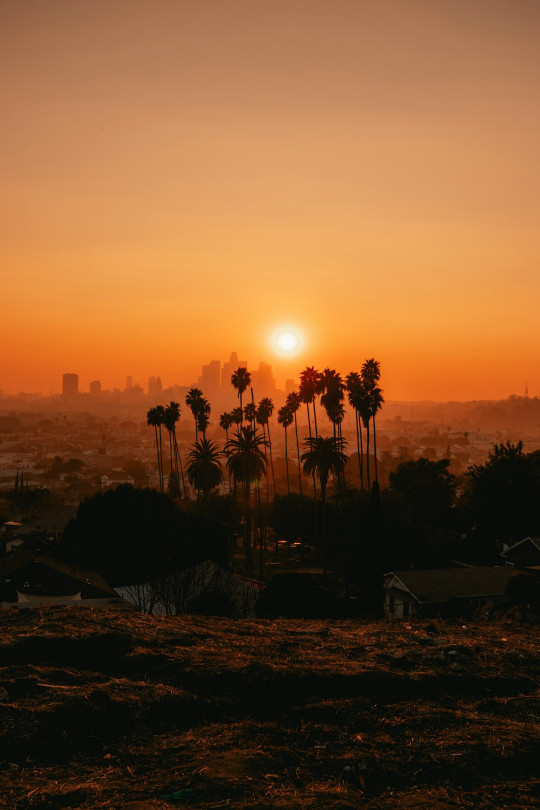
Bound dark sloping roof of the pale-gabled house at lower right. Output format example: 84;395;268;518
385;566;515;602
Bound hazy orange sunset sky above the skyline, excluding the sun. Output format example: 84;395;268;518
0;0;540;399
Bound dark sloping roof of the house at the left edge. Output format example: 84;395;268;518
0;549;117;602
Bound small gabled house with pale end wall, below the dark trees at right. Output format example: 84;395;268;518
384;566;515;618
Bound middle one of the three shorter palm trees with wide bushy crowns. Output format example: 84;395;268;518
225;427;268;566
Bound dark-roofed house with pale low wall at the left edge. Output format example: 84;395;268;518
0;549;122;608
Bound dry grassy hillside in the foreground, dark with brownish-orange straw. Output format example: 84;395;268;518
0;608;540;810
